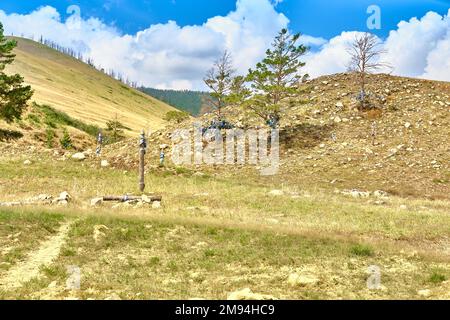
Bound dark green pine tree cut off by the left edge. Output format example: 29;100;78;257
0;23;33;122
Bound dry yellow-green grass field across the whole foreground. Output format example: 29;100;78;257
0;155;450;299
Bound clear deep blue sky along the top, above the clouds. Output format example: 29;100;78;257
0;0;450;39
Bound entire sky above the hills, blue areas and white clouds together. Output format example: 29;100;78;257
0;0;450;90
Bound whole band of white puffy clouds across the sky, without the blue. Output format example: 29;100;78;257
0;0;450;89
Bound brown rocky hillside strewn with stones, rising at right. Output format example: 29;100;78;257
96;74;450;199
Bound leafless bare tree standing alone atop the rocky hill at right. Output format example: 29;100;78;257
347;32;390;110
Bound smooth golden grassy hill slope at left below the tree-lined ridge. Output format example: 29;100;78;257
8;38;178;132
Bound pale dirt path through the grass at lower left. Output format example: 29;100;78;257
0;222;73;290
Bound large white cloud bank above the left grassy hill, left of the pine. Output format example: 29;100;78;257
0;0;298;89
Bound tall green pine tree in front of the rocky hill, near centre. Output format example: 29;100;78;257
247;29;308;127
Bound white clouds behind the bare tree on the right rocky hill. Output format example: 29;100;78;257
306;10;450;81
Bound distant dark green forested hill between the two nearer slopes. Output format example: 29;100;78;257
139;87;208;116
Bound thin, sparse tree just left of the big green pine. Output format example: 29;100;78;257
203;51;235;118
